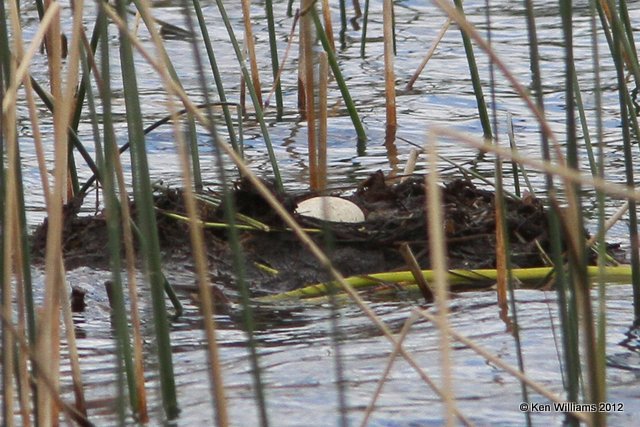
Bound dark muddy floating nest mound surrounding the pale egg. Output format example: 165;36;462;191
32;172;600;292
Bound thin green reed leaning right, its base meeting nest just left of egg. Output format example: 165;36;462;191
216;0;284;191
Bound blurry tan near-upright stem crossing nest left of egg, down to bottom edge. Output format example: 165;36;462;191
134;0;229;427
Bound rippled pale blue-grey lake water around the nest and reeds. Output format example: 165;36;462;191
11;0;640;426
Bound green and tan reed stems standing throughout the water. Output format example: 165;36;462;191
0;0;640;426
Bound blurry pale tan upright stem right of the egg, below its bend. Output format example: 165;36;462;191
425;136;456;426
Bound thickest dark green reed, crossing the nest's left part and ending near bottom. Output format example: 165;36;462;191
112;0;179;419
